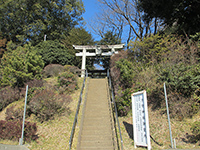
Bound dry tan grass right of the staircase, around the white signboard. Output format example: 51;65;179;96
119;107;200;150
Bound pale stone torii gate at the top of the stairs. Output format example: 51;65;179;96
73;44;124;77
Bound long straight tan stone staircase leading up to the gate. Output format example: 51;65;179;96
77;78;114;150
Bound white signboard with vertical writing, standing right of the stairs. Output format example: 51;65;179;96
131;91;151;150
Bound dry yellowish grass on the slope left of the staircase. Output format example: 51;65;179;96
0;78;83;150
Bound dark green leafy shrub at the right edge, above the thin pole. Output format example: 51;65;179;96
157;63;200;97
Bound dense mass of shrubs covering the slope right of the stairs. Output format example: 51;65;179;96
110;35;200;120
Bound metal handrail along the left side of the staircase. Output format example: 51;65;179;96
69;70;88;150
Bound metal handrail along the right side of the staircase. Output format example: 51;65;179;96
107;69;123;150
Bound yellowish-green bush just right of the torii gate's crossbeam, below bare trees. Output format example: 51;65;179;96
128;34;170;66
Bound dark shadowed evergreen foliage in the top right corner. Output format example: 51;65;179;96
139;0;200;35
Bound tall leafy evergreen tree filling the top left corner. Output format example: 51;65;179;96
0;0;84;45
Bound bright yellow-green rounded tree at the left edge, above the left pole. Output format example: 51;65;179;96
0;43;44;87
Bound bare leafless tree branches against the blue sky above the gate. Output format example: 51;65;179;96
89;0;162;43
